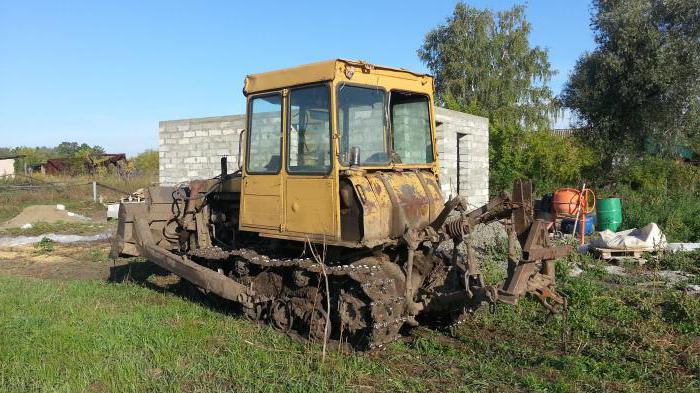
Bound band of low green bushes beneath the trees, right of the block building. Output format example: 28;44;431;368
490;136;700;242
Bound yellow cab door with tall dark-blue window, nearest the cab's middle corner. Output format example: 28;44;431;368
284;84;338;239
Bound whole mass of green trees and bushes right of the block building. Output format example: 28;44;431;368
418;0;700;241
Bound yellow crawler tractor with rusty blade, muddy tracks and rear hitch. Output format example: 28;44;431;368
112;60;570;349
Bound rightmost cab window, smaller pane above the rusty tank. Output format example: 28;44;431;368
389;92;433;164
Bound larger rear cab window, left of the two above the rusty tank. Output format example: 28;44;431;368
338;85;389;165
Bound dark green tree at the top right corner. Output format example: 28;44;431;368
562;0;700;162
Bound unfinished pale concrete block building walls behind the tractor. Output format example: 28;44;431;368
160;108;489;207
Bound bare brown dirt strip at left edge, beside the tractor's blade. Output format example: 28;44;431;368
0;241;127;280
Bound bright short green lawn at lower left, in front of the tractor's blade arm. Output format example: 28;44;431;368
0;277;412;392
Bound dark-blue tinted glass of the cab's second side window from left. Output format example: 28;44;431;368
287;85;331;174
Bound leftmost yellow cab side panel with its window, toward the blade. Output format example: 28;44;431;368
240;92;284;232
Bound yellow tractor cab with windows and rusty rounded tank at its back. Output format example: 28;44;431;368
239;59;443;247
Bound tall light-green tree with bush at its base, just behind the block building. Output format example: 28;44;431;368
418;2;576;191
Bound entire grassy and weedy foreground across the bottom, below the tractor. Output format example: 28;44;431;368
0;256;700;392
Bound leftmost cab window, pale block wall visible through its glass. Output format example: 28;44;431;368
246;94;282;173
